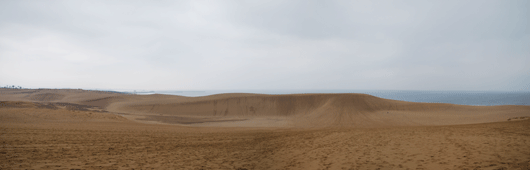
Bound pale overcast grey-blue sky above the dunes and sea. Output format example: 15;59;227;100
0;0;530;91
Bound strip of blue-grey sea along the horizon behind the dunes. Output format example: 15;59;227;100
130;90;530;106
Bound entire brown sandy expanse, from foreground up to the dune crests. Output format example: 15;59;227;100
0;89;530;169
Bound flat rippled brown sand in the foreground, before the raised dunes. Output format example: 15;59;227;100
0;102;530;170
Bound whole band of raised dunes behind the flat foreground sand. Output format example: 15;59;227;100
0;90;530;128
